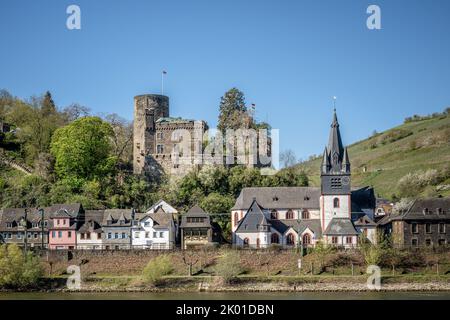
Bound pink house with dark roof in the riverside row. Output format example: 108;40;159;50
48;204;83;250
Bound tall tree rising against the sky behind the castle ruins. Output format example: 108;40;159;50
217;88;253;132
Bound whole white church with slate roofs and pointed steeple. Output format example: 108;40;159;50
231;110;376;248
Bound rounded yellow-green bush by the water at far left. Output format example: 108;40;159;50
0;244;44;288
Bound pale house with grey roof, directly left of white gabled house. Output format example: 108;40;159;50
102;209;135;250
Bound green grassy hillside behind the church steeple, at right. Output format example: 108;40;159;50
299;110;450;199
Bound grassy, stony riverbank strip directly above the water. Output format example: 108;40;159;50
3;276;450;295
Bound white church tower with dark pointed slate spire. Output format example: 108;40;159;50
320;110;351;230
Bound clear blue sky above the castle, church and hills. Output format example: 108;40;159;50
0;0;450;159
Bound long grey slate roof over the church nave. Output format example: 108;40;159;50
232;187;320;210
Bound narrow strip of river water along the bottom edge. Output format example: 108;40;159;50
0;291;450;300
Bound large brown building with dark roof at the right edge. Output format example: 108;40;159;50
378;197;450;247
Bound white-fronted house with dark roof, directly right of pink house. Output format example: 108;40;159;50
76;210;104;250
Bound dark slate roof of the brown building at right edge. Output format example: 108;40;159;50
378;197;450;225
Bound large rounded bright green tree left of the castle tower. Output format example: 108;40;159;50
51;117;116;180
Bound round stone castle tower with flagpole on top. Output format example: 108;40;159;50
133;94;169;174
